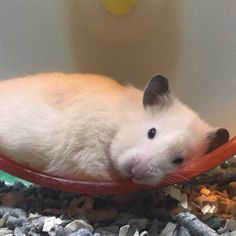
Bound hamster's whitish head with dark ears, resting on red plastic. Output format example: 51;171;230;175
111;75;229;185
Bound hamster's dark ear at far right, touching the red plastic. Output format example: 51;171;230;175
206;128;229;153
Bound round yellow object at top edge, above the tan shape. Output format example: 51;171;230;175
102;0;137;16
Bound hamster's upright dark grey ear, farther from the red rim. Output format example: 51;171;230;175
143;75;171;107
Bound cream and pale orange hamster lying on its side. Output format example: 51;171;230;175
0;73;229;185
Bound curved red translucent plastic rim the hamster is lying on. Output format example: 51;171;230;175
0;137;236;195
